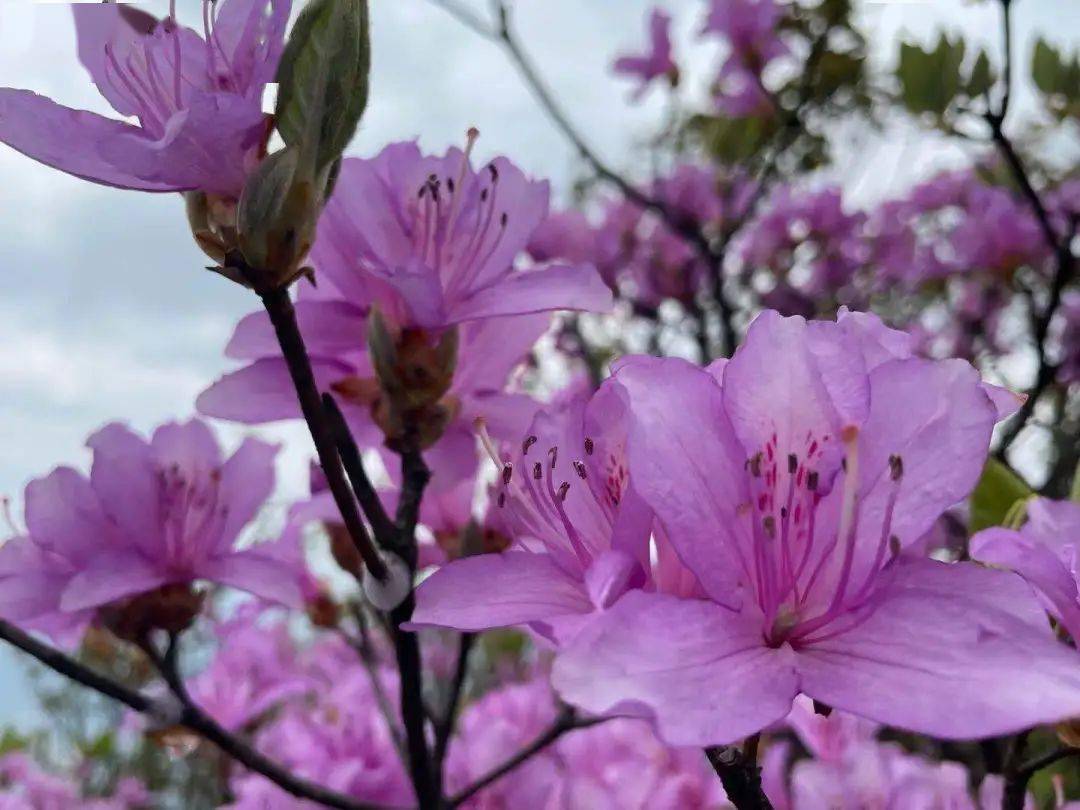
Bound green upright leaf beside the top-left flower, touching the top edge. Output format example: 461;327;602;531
274;0;372;174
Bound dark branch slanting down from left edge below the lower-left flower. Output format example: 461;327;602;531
0;619;388;810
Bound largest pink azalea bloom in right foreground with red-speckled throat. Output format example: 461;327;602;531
553;312;1080;745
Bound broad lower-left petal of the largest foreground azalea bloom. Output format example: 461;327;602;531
552;591;798;745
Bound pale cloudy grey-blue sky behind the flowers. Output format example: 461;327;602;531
0;0;1080;726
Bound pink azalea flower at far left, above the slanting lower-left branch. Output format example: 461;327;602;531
0;421;300;640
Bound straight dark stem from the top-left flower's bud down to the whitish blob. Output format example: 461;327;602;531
260;288;387;580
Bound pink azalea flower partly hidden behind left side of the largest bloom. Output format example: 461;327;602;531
413;384;651;640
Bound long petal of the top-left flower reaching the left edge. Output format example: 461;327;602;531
0;87;177;191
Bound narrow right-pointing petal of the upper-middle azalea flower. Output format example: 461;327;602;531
447;265;613;323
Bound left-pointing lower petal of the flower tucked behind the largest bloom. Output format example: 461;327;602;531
411;551;593;631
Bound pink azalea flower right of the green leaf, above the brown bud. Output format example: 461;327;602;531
295;139;611;332
